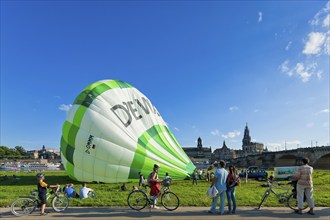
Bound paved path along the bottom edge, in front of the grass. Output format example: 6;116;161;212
0;207;330;220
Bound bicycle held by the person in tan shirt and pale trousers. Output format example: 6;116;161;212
257;180;308;210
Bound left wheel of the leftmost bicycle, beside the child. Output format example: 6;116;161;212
10;198;37;216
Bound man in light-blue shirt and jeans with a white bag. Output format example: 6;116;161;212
208;160;228;215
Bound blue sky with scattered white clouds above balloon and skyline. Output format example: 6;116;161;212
0;1;330;150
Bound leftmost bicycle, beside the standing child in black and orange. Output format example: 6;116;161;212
10;187;69;216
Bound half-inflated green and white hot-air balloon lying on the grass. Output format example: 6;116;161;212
61;80;195;183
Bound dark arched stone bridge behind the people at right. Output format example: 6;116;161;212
233;146;330;170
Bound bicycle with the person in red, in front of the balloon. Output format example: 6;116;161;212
127;181;180;211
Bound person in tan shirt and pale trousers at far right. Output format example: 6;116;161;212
292;158;315;215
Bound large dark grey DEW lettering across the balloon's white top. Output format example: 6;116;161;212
111;97;160;127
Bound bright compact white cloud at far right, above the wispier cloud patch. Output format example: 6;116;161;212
303;32;326;55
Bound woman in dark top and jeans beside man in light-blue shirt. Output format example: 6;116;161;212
226;165;240;214
